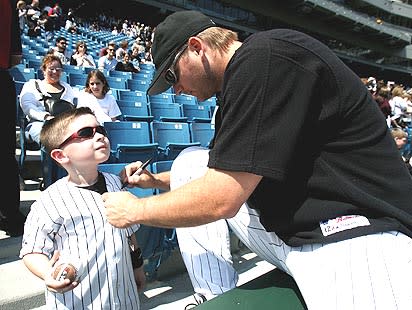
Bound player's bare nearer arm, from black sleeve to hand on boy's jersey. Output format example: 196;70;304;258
102;168;262;227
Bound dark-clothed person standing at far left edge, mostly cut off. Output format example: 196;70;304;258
0;0;25;237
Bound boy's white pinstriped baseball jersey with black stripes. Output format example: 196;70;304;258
20;173;140;310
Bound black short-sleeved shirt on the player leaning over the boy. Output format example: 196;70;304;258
209;29;412;246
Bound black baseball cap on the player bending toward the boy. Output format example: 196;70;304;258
147;11;216;95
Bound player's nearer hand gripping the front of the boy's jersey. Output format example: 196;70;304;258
102;191;138;228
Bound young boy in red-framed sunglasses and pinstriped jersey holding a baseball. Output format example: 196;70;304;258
20;107;145;309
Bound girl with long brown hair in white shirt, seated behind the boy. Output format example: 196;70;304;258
77;70;122;124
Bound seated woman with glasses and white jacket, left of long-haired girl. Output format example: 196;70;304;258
20;54;75;145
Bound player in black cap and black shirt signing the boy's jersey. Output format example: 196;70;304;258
103;11;412;309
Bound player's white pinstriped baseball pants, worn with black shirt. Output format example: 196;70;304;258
171;147;412;310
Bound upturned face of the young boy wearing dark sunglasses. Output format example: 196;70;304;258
61;114;110;169
